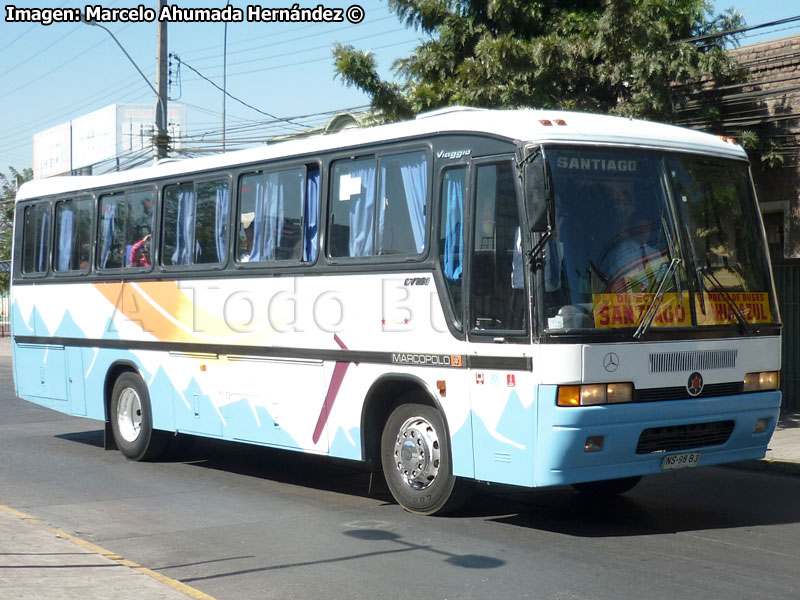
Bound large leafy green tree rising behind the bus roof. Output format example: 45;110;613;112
334;0;743;121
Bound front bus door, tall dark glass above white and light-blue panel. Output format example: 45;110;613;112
465;156;536;485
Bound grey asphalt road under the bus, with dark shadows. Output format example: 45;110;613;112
0;357;800;600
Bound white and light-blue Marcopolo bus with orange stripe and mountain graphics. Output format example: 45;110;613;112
12;108;780;514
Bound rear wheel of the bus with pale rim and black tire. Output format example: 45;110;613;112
109;372;169;460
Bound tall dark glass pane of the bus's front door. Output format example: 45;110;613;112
471;163;527;332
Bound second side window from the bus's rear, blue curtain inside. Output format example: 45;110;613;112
53;198;92;273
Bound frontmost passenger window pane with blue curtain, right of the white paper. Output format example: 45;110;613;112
378;152;428;254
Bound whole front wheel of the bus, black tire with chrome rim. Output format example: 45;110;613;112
381;404;466;515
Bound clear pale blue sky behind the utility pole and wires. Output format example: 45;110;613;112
0;0;800;172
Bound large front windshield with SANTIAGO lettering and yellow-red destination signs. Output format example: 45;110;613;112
543;148;775;333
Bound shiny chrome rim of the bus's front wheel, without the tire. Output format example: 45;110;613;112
394;417;441;490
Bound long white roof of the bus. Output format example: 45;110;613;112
17;107;747;201
